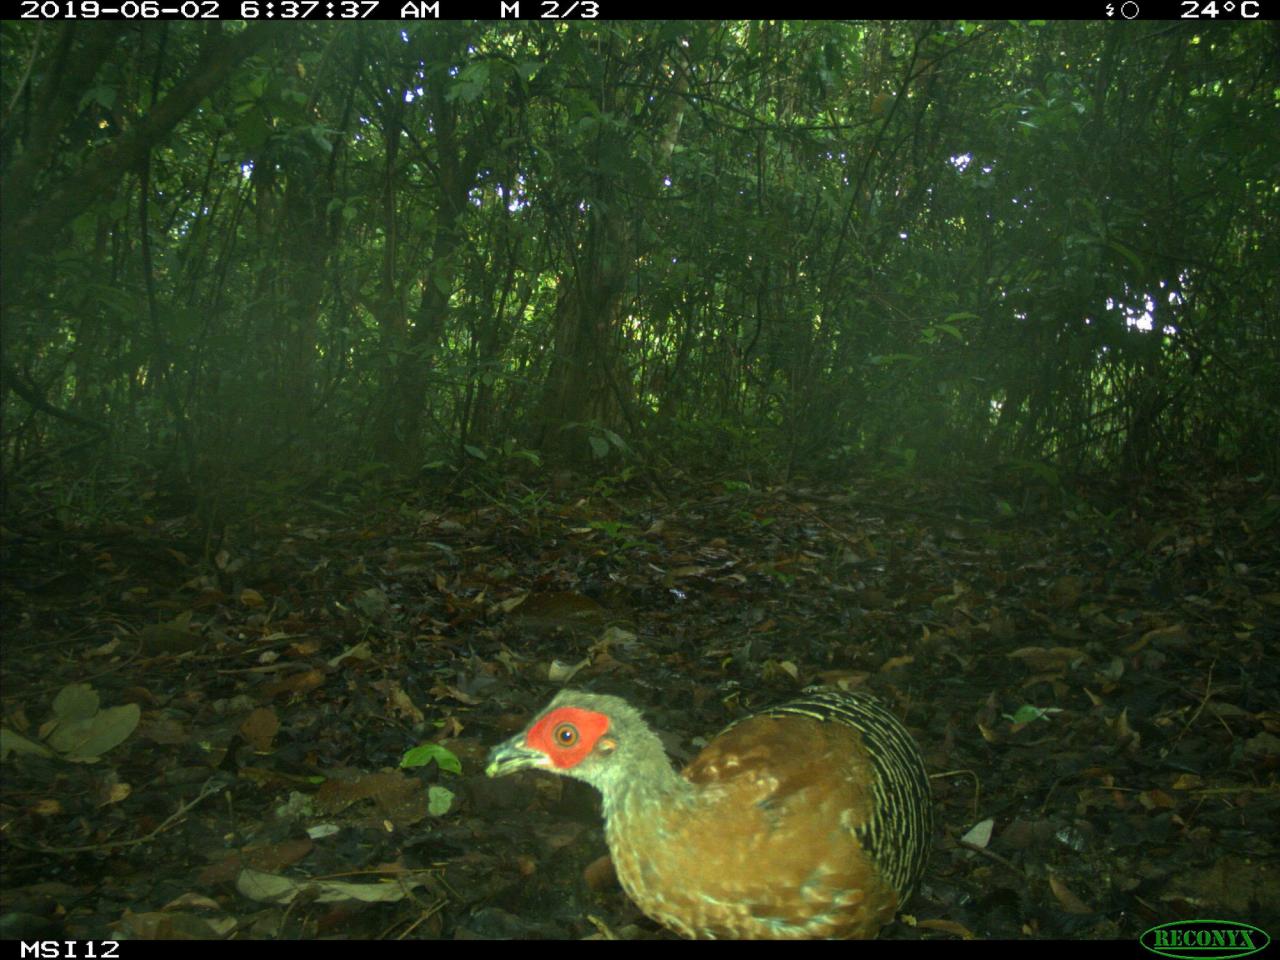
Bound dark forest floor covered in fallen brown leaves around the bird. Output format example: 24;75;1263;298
0;477;1280;940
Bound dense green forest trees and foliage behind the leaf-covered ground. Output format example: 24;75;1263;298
0;22;1280;522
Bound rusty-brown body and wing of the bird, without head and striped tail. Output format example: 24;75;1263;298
611;716;897;937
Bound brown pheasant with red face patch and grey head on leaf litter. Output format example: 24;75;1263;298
485;690;933;940
